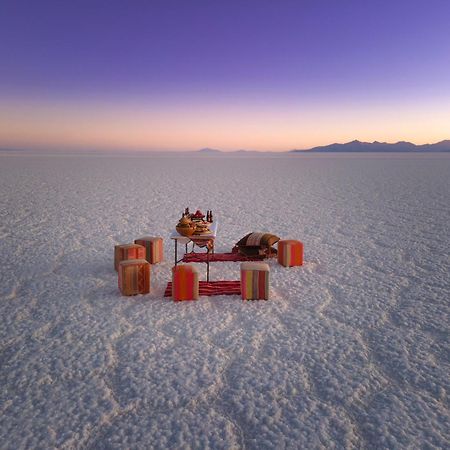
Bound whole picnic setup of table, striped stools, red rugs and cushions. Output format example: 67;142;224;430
114;208;303;301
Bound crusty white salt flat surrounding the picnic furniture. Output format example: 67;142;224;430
0;153;450;450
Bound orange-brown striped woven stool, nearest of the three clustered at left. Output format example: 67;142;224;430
119;259;151;295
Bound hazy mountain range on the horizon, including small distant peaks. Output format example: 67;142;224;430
198;139;450;155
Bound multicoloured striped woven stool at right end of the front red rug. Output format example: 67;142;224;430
241;262;269;300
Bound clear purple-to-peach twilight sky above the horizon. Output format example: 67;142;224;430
0;0;450;151
